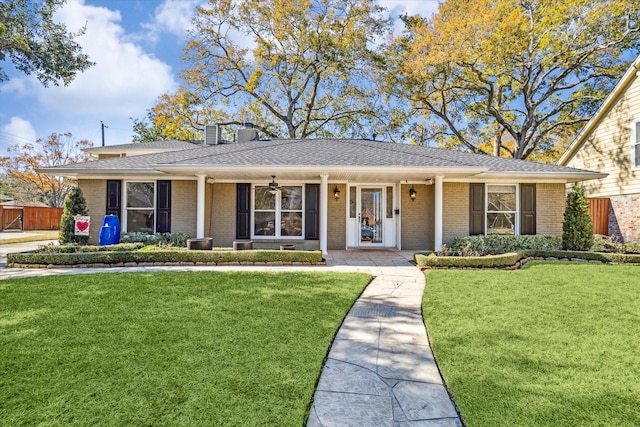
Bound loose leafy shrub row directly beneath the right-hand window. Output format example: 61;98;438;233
451;234;562;256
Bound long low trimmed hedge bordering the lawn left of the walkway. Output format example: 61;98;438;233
7;250;322;266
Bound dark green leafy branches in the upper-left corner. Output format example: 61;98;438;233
0;0;94;87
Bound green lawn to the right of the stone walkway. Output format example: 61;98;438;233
423;263;640;427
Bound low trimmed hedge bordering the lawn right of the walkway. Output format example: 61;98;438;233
413;250;640;268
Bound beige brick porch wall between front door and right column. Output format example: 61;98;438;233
400;185;434;250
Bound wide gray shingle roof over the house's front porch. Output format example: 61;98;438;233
44;139;604;175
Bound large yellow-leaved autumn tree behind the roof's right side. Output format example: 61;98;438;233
387;0;640;159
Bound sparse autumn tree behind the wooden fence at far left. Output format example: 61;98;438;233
0;133;92;207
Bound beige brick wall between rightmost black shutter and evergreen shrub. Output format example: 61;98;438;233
536;184;566;236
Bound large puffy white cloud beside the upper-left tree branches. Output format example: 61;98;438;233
3;0;177;117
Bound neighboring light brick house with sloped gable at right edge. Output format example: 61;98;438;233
558;57;640;242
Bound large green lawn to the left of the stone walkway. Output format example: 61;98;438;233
0;272;369;426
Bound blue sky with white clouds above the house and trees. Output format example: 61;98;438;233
0;0;437;156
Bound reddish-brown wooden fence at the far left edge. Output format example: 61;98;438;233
0;206;63;231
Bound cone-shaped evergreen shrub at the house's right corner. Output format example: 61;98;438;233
562;184;593;251
